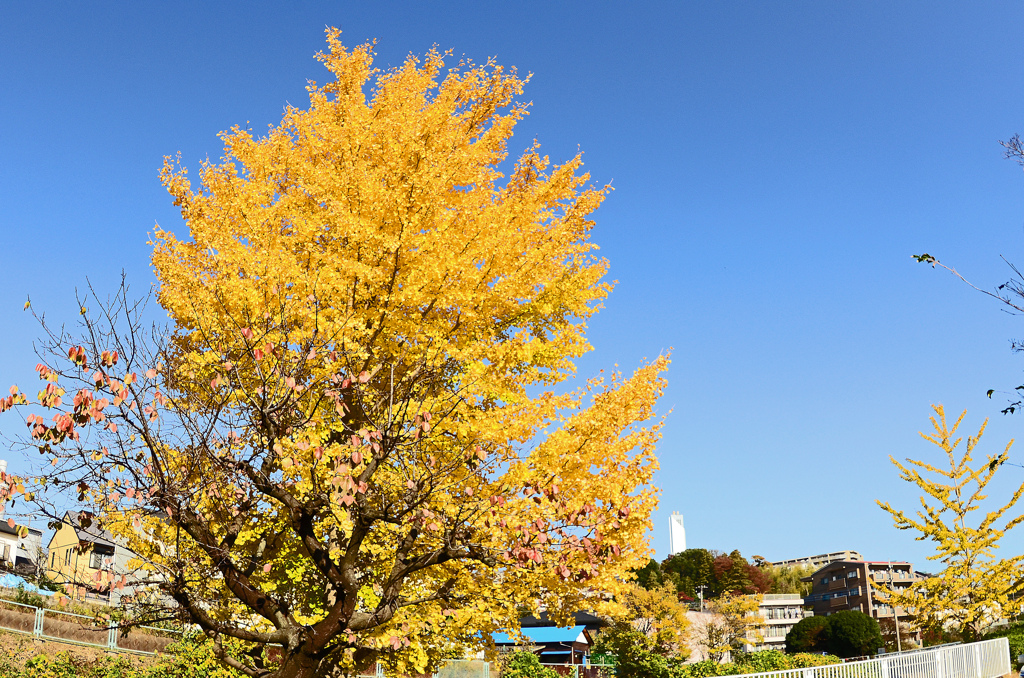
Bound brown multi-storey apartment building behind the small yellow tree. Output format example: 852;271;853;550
804;560;925;622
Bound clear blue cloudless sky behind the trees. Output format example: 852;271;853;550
0;1;1024;567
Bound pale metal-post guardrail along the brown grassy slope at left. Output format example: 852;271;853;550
0;600;181;654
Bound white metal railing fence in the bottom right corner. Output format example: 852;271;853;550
746;638;1010;678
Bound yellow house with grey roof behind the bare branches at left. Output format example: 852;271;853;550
46;512;134;605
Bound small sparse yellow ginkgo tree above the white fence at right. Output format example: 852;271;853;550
871;405;1024;640
